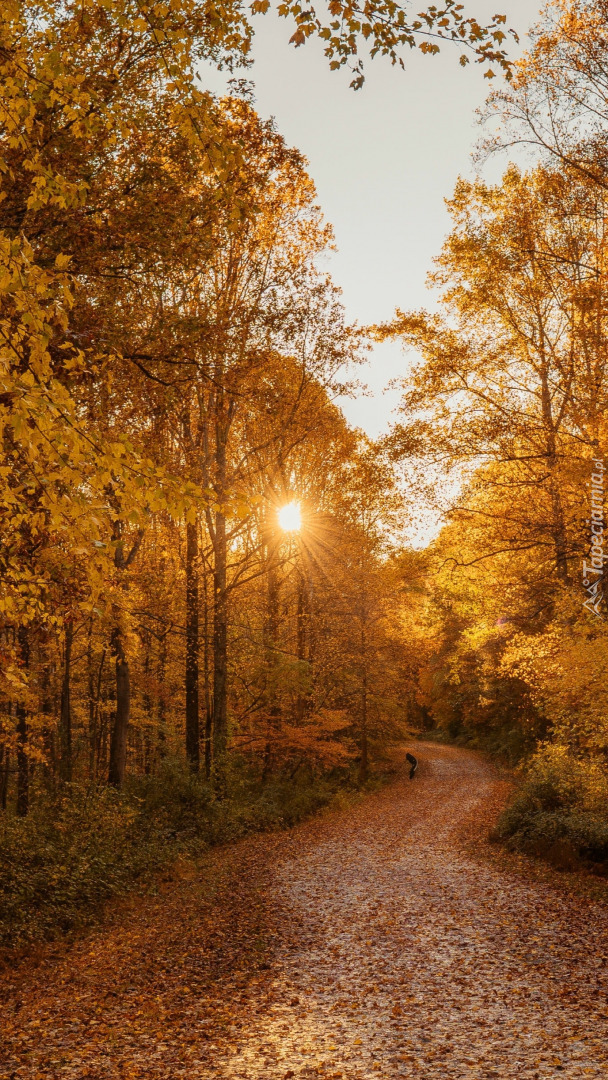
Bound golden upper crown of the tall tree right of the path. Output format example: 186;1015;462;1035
379;162;606;595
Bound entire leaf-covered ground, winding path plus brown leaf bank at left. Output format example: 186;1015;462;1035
0;744;608;1080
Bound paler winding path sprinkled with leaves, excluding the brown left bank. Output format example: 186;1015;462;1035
218;744;608;1080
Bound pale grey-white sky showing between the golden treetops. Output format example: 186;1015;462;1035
203;0;540;437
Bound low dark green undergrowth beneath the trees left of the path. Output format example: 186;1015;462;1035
0;758;358;946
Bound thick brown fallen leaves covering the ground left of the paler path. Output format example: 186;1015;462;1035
0;837;272;1080
